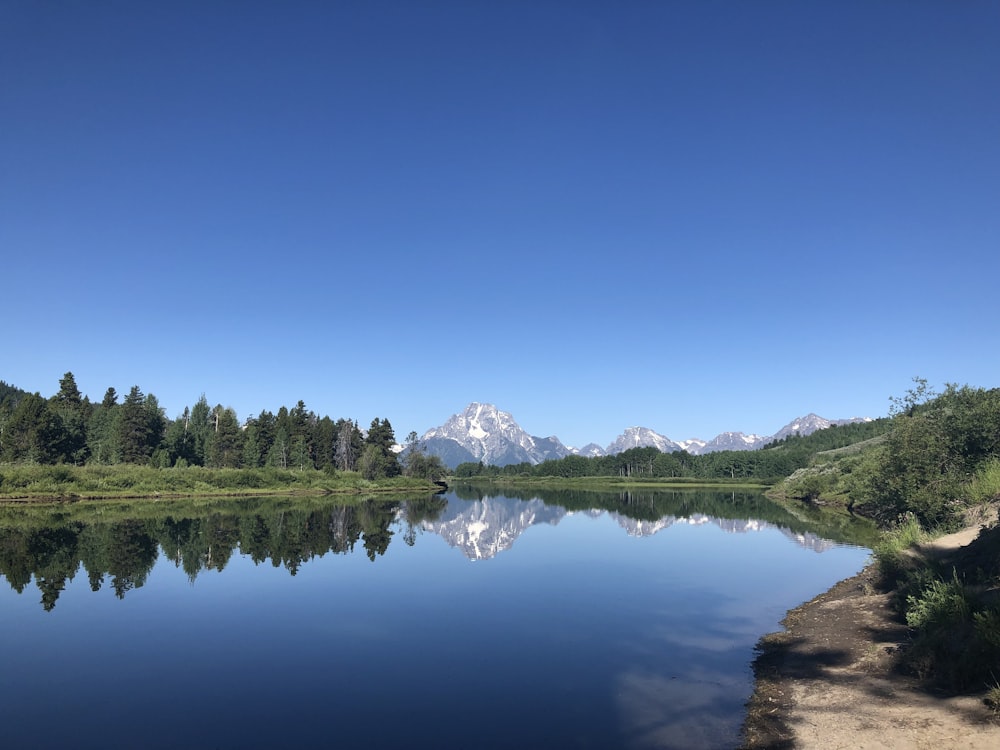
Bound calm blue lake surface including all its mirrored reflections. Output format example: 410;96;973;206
0;488;870;749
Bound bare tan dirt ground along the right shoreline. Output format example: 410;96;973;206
744;527;1000;750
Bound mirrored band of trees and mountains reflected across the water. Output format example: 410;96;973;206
0;488;868;611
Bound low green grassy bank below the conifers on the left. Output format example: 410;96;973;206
0;464;437;500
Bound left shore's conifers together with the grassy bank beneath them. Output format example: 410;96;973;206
0;372;447;498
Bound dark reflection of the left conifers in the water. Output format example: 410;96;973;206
0;497;447;611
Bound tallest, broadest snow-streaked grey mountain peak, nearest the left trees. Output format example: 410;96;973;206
419;402;570;468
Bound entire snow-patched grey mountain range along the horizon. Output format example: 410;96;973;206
419;402;871;469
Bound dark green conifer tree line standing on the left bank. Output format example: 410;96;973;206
0;372;444;479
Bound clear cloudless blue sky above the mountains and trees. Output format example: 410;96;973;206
0;0;1000;447
